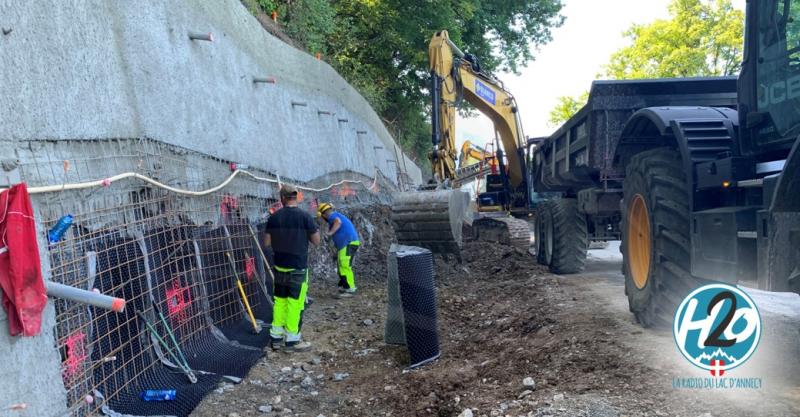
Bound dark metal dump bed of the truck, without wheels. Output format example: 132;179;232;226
533;77;736;193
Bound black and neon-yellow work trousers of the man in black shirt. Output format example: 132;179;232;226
270;266;308;342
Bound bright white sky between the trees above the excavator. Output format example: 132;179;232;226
456;0;745;148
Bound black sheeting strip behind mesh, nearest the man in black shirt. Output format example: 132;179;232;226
197;224;272;348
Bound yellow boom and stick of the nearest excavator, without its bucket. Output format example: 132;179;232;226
428;30;525;188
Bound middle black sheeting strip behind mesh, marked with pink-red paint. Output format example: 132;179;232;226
145;228;263;378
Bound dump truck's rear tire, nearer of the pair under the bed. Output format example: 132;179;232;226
550;198;589;274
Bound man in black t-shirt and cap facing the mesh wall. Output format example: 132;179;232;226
264;184;320;351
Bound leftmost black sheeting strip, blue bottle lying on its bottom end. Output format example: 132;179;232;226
90;238;220;416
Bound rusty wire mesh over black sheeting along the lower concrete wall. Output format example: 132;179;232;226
20;139;390;416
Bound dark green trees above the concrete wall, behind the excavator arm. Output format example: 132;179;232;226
250;0;563;171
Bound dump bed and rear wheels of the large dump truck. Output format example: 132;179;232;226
529;77;736;274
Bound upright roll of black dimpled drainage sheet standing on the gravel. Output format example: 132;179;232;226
384;245;441;368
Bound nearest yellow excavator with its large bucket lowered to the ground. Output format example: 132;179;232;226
392;31;530;255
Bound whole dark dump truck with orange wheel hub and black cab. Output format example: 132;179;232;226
531;0;800;326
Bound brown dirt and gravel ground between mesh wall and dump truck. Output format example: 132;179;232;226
193;207;800;417
